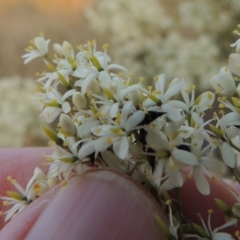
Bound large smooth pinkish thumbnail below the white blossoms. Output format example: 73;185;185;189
23;170;166;240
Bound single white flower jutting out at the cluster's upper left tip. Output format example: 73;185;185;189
22;36;50;64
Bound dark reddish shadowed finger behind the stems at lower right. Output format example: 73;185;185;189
181;177;240;234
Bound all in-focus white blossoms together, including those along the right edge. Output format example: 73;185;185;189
2;26;240;239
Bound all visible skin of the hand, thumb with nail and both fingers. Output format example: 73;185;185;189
0;148;240;240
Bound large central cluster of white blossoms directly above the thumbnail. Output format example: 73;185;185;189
23;36;222;194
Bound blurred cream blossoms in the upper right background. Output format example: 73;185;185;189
86;0;240;89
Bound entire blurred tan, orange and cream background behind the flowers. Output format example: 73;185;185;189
0;0;240;147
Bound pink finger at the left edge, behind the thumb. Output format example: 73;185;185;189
0;148;52;229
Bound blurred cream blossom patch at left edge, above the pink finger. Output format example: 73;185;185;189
0;77;47;147
